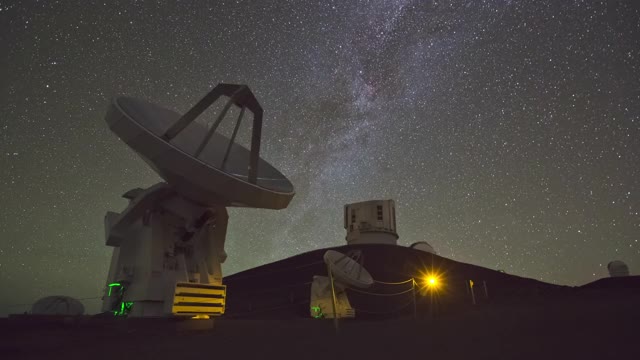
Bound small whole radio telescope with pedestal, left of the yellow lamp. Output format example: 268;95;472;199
311;250;373;319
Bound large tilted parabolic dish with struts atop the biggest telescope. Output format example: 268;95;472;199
106;84;294;209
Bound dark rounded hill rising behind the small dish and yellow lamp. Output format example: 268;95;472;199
224;244;571;319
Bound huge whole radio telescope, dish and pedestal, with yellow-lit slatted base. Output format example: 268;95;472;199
103;84;294;317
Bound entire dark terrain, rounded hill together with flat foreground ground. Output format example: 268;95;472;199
0;245;640;360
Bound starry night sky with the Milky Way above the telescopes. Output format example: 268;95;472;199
0;0;640;315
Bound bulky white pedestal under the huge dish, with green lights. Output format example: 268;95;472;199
103;183;228;317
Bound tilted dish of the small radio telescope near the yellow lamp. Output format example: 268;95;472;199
324;250;373;288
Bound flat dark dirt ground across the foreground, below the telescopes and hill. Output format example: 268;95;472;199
0;295;640;360
